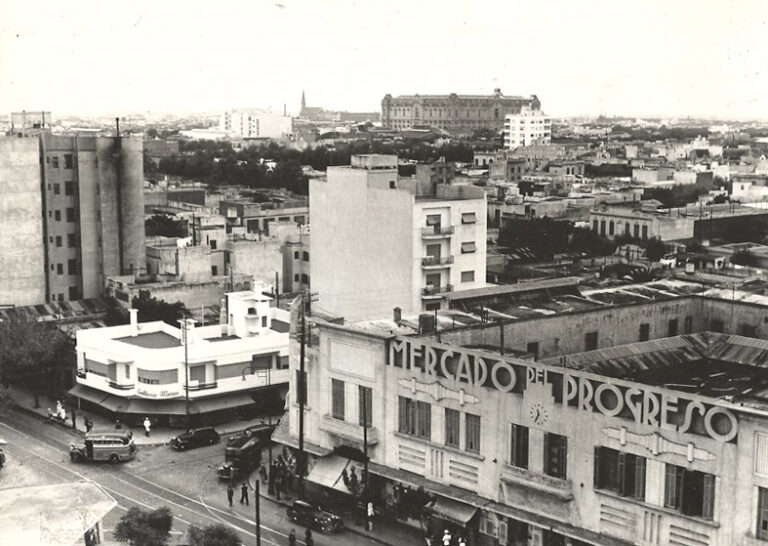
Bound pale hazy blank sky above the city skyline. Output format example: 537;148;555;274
0;0;768;119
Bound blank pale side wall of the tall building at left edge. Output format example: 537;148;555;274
0;138;46;306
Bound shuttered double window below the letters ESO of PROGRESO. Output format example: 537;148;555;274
664;463;715;520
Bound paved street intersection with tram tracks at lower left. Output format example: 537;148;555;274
0;410;384;546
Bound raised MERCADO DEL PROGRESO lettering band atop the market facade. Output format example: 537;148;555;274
387;336;738;442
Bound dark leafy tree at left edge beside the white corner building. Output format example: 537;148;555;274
0;320;75;408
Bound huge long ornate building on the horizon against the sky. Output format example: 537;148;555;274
381;89;541;133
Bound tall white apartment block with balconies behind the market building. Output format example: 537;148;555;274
309;155;486;320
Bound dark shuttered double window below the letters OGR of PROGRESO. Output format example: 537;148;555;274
594;447;645;500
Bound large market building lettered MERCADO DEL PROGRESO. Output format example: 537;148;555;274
275;296;768;546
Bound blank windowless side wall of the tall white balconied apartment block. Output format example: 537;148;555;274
309;167;418;320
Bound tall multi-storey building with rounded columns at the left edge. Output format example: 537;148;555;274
0;132;145;306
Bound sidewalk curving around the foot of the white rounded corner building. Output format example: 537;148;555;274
0;385;274;446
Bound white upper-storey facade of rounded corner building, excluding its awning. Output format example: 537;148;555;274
76;291;290;400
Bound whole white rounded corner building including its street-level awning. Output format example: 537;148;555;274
70;291;289;426
